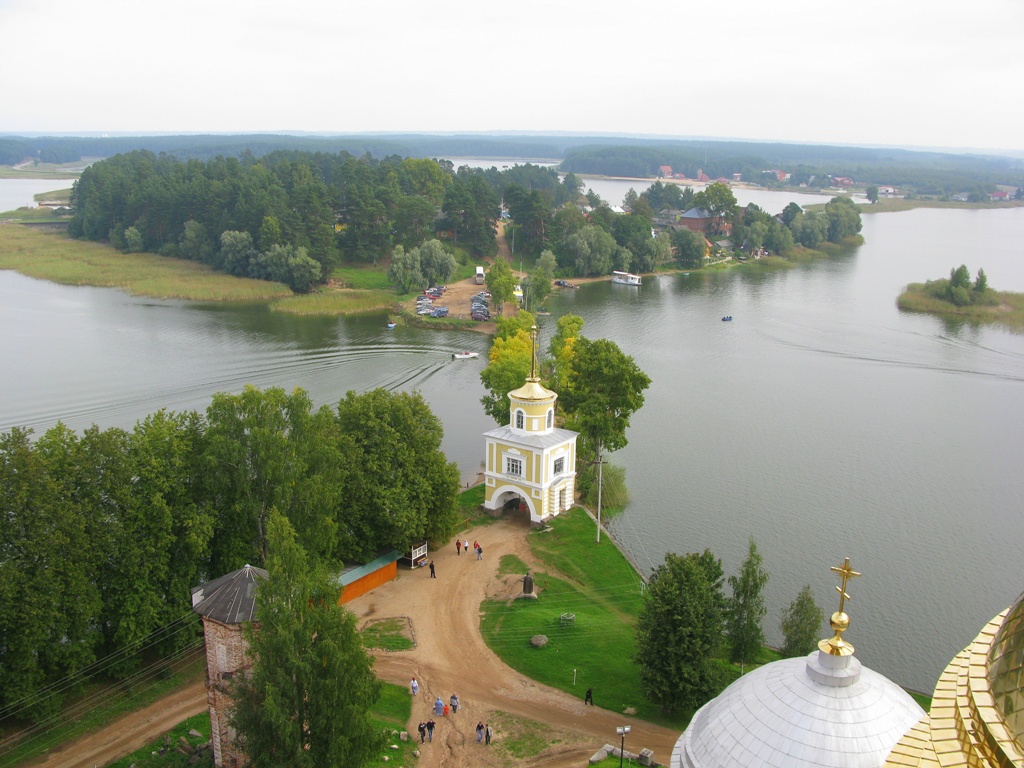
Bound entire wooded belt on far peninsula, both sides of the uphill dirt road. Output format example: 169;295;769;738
69;145;860;292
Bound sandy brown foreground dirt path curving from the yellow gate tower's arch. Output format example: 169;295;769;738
39;519;679;768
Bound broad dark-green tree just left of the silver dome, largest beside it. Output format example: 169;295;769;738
633;550;724;714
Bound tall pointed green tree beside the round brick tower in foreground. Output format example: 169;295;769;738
230;512;384;768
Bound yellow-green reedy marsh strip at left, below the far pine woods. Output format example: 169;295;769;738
0;224;292;301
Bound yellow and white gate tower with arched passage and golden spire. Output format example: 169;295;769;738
483;326;579;524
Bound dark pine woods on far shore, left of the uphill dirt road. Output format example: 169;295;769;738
69;151;579;291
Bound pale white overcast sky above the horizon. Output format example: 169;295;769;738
0;0;1024;151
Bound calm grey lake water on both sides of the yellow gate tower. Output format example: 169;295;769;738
0;176;1024;691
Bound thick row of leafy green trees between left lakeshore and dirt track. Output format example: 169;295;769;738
0;388;459;720
